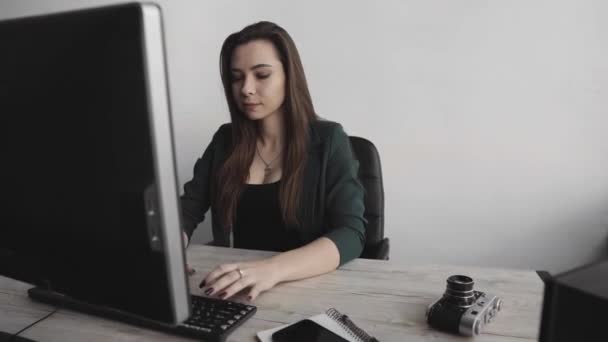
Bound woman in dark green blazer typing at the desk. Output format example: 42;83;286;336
181;22;366;301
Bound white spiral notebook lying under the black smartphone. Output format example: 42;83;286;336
257;308;378;342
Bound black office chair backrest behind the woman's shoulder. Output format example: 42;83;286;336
350;137;390;260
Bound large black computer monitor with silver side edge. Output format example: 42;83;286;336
0;3;190;324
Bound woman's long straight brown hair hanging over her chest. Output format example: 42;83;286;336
216;21;317;229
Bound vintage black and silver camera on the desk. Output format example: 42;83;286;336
426;275;502;336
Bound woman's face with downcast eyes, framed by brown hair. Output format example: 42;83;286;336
230;40;285;120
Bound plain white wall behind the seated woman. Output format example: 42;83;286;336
0;0;608;271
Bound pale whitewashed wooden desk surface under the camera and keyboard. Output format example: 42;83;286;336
0;246;543;342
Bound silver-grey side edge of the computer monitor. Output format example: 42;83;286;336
139;3;190;323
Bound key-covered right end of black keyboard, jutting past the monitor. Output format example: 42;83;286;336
176;295;257;342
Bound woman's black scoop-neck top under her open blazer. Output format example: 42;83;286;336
233;181;303;252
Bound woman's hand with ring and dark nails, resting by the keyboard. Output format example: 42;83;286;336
200;259;280;301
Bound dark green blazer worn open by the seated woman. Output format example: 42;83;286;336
181;120;367;265
